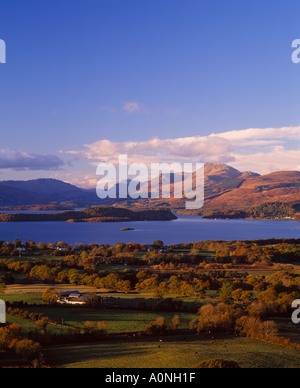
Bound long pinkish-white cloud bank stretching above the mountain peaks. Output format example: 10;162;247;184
63;127;300;174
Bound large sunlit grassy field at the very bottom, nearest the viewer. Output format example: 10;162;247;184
44;337;300;368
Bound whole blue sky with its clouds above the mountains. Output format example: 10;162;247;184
0;0;300;186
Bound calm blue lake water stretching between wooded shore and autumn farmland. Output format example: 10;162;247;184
0;216;300;244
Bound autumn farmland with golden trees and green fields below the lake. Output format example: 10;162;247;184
0;236;300;368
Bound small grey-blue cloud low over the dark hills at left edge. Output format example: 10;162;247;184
0;149;64;171
